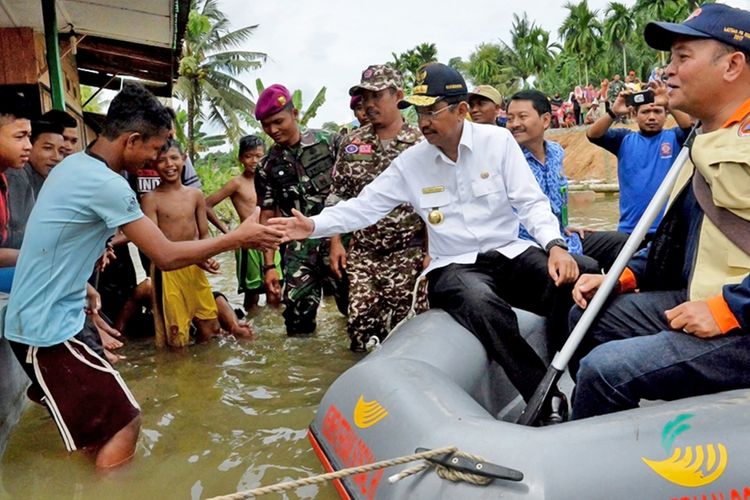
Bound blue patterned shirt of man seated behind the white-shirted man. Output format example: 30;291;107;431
518;141;583;255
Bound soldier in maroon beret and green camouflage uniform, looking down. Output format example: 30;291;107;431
255;84;346;335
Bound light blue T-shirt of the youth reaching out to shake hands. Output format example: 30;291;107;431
5;152;143;347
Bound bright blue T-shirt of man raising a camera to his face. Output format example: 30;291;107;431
591;127;688;234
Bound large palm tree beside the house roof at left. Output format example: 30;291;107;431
175;0;266;160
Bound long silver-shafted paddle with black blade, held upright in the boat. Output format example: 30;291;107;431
518;123;700;425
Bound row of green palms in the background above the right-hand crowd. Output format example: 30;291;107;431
462;0;714;95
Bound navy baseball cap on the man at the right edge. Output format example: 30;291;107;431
643;3;750;52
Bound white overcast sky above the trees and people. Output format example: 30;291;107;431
219;0;750;131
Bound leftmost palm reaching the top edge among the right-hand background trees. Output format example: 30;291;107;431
559;0;602;85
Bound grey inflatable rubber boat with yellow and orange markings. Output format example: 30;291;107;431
309;310;750;500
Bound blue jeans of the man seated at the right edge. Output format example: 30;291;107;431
571;290;750;419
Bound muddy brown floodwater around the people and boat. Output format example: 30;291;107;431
0;193;618;500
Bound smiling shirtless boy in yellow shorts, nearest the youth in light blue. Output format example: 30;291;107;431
141;139;247;347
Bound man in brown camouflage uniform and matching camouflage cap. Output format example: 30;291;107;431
326;65;426;352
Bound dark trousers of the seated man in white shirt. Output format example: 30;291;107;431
428;247;597;401
